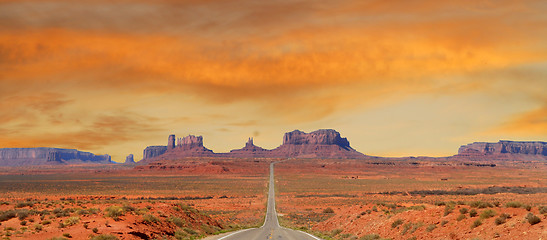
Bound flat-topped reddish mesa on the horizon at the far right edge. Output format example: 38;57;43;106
455;141;547;160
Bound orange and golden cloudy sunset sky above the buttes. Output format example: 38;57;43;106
0;0;547;162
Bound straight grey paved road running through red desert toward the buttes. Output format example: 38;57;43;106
217;163;321;240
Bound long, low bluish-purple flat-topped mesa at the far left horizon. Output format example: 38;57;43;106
0;147;112;166
